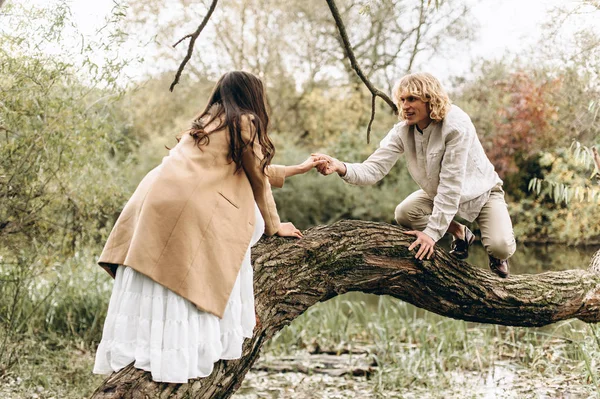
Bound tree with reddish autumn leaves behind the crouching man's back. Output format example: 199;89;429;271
456;62;600;199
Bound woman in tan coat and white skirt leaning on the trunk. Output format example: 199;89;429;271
94;72;319;383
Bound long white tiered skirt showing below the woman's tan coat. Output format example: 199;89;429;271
93;206;264;383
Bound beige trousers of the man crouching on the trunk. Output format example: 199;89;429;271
395;186;517;259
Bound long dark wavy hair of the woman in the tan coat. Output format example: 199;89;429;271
189;71;275;173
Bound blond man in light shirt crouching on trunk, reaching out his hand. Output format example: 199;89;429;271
314;73;516;278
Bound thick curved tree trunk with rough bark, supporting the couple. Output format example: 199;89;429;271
92;221;600;399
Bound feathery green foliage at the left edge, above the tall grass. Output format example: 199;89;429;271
0;3;134;253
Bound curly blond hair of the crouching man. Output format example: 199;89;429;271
392;73;452;122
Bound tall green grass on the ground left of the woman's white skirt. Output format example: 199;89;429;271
0;253;112;399
